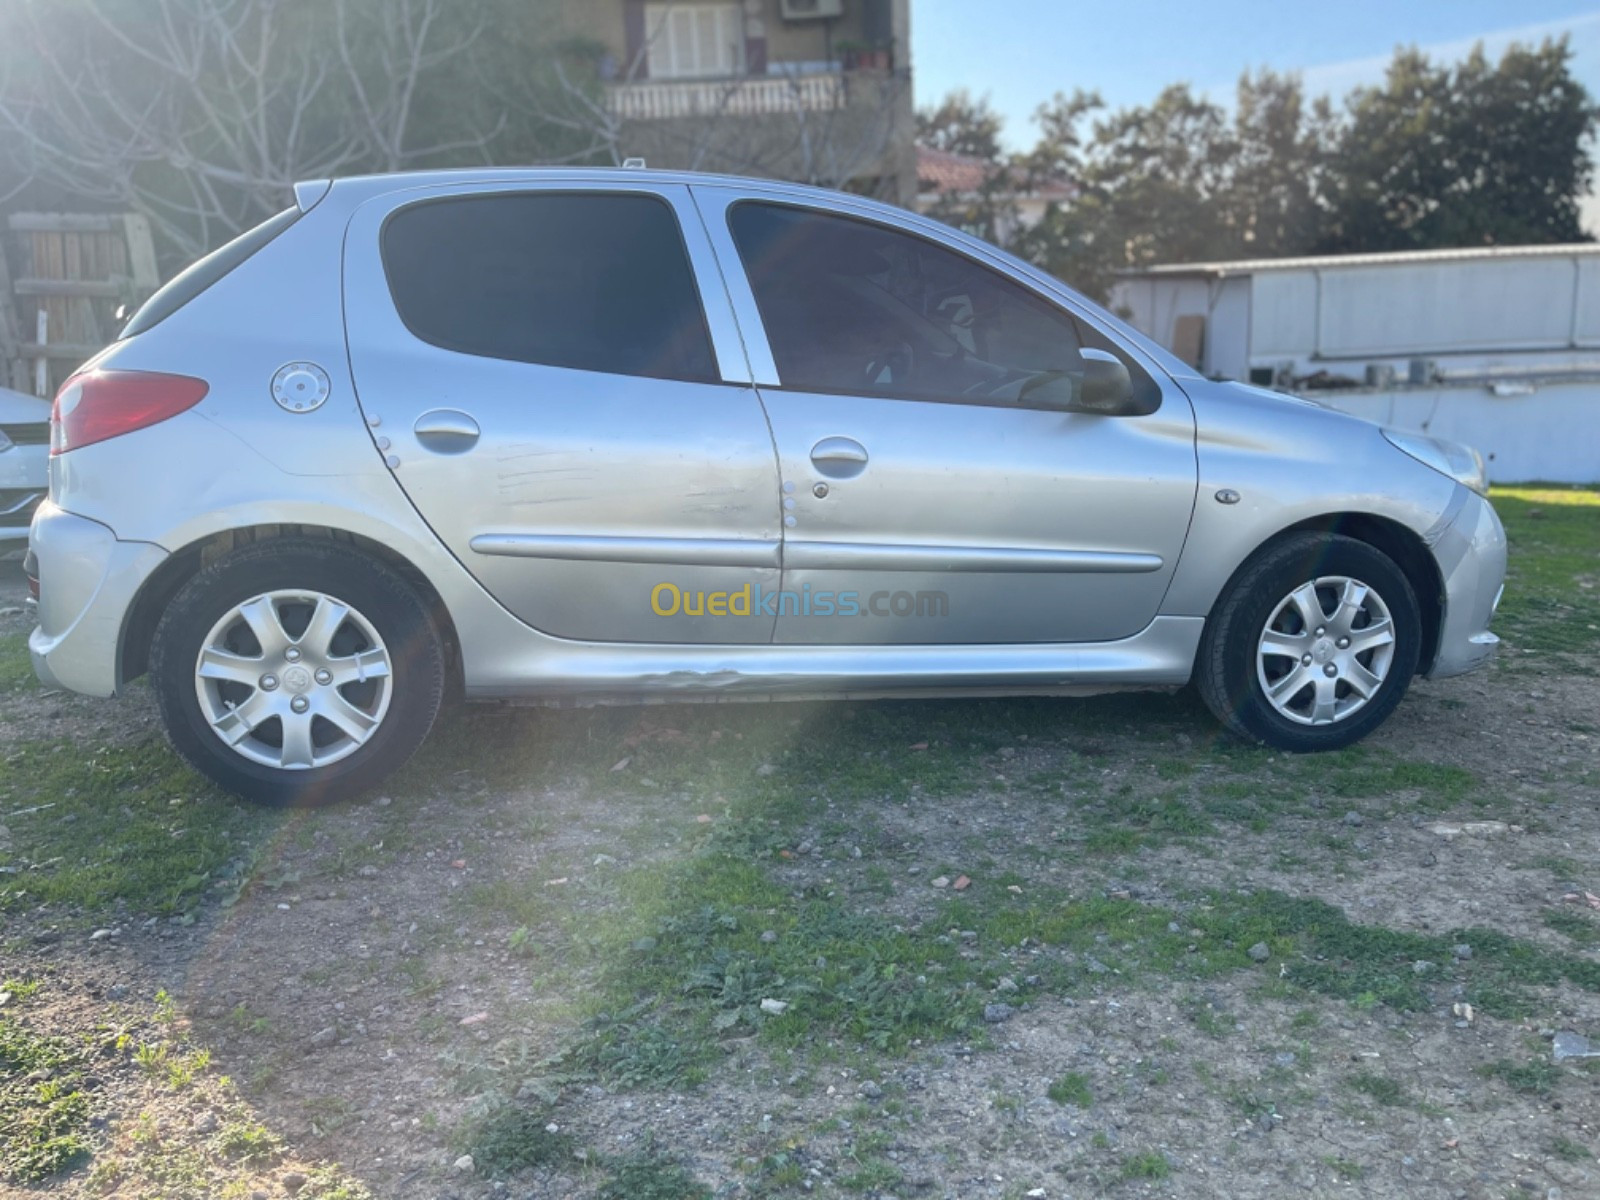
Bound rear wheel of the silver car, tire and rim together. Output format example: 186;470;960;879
150;539;446;805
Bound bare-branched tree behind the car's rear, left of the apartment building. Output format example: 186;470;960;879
0;0;506;256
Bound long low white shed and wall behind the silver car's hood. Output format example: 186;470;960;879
1112;243;1600;483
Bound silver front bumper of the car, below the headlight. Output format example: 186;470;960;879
1427;488;1506;678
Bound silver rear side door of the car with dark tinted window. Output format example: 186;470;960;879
344;181;781;643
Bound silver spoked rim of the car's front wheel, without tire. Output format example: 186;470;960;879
1256;574;1395;725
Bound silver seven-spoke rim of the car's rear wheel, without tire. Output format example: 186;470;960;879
195;590;392;771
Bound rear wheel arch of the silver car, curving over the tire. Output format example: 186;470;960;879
117;525;464;699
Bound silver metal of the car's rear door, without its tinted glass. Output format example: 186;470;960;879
346;186;781;643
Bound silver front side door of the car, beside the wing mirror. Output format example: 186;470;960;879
694;186;1197;643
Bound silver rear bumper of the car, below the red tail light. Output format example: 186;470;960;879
27;501;166;696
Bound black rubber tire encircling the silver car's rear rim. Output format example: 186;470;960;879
150;538;446;808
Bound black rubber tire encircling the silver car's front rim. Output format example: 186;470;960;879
1195;533;1422;754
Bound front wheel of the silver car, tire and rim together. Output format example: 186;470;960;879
1197;533;1422;752
